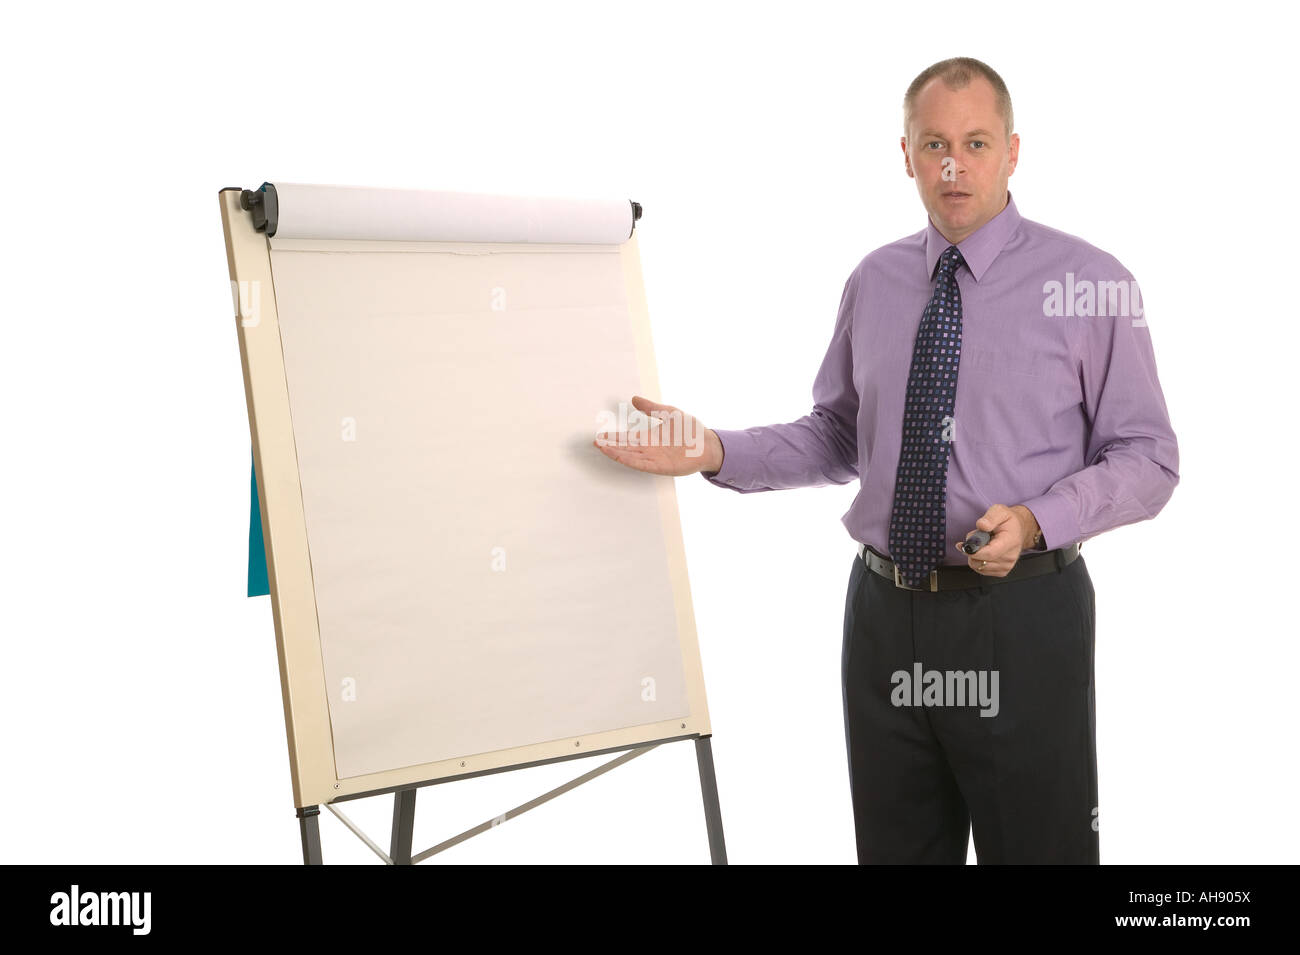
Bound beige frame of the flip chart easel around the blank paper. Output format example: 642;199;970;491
218;188;725;861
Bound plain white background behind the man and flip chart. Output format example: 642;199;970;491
0;1;1300;864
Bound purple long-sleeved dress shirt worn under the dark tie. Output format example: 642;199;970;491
703;194;1178;565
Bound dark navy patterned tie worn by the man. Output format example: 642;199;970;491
889;246;963;587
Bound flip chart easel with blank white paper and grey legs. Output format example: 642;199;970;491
218;183;727;864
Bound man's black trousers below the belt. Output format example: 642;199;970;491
841;545;1099;864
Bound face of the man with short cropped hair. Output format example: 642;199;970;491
902;77;1021;244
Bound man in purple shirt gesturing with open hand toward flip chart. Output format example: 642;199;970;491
597;57;1178;864
